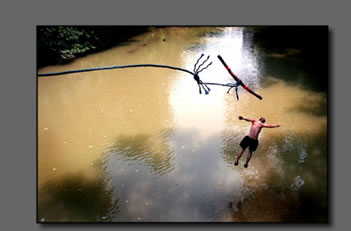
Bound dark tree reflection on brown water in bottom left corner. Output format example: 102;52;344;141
38;159;120;222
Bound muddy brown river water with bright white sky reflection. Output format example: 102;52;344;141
37;27;328;222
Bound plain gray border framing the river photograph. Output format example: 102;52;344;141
0;0;351;230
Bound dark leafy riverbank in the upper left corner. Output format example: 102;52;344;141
37;26;151;68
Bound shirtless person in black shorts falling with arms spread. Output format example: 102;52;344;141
234;116;281;168
